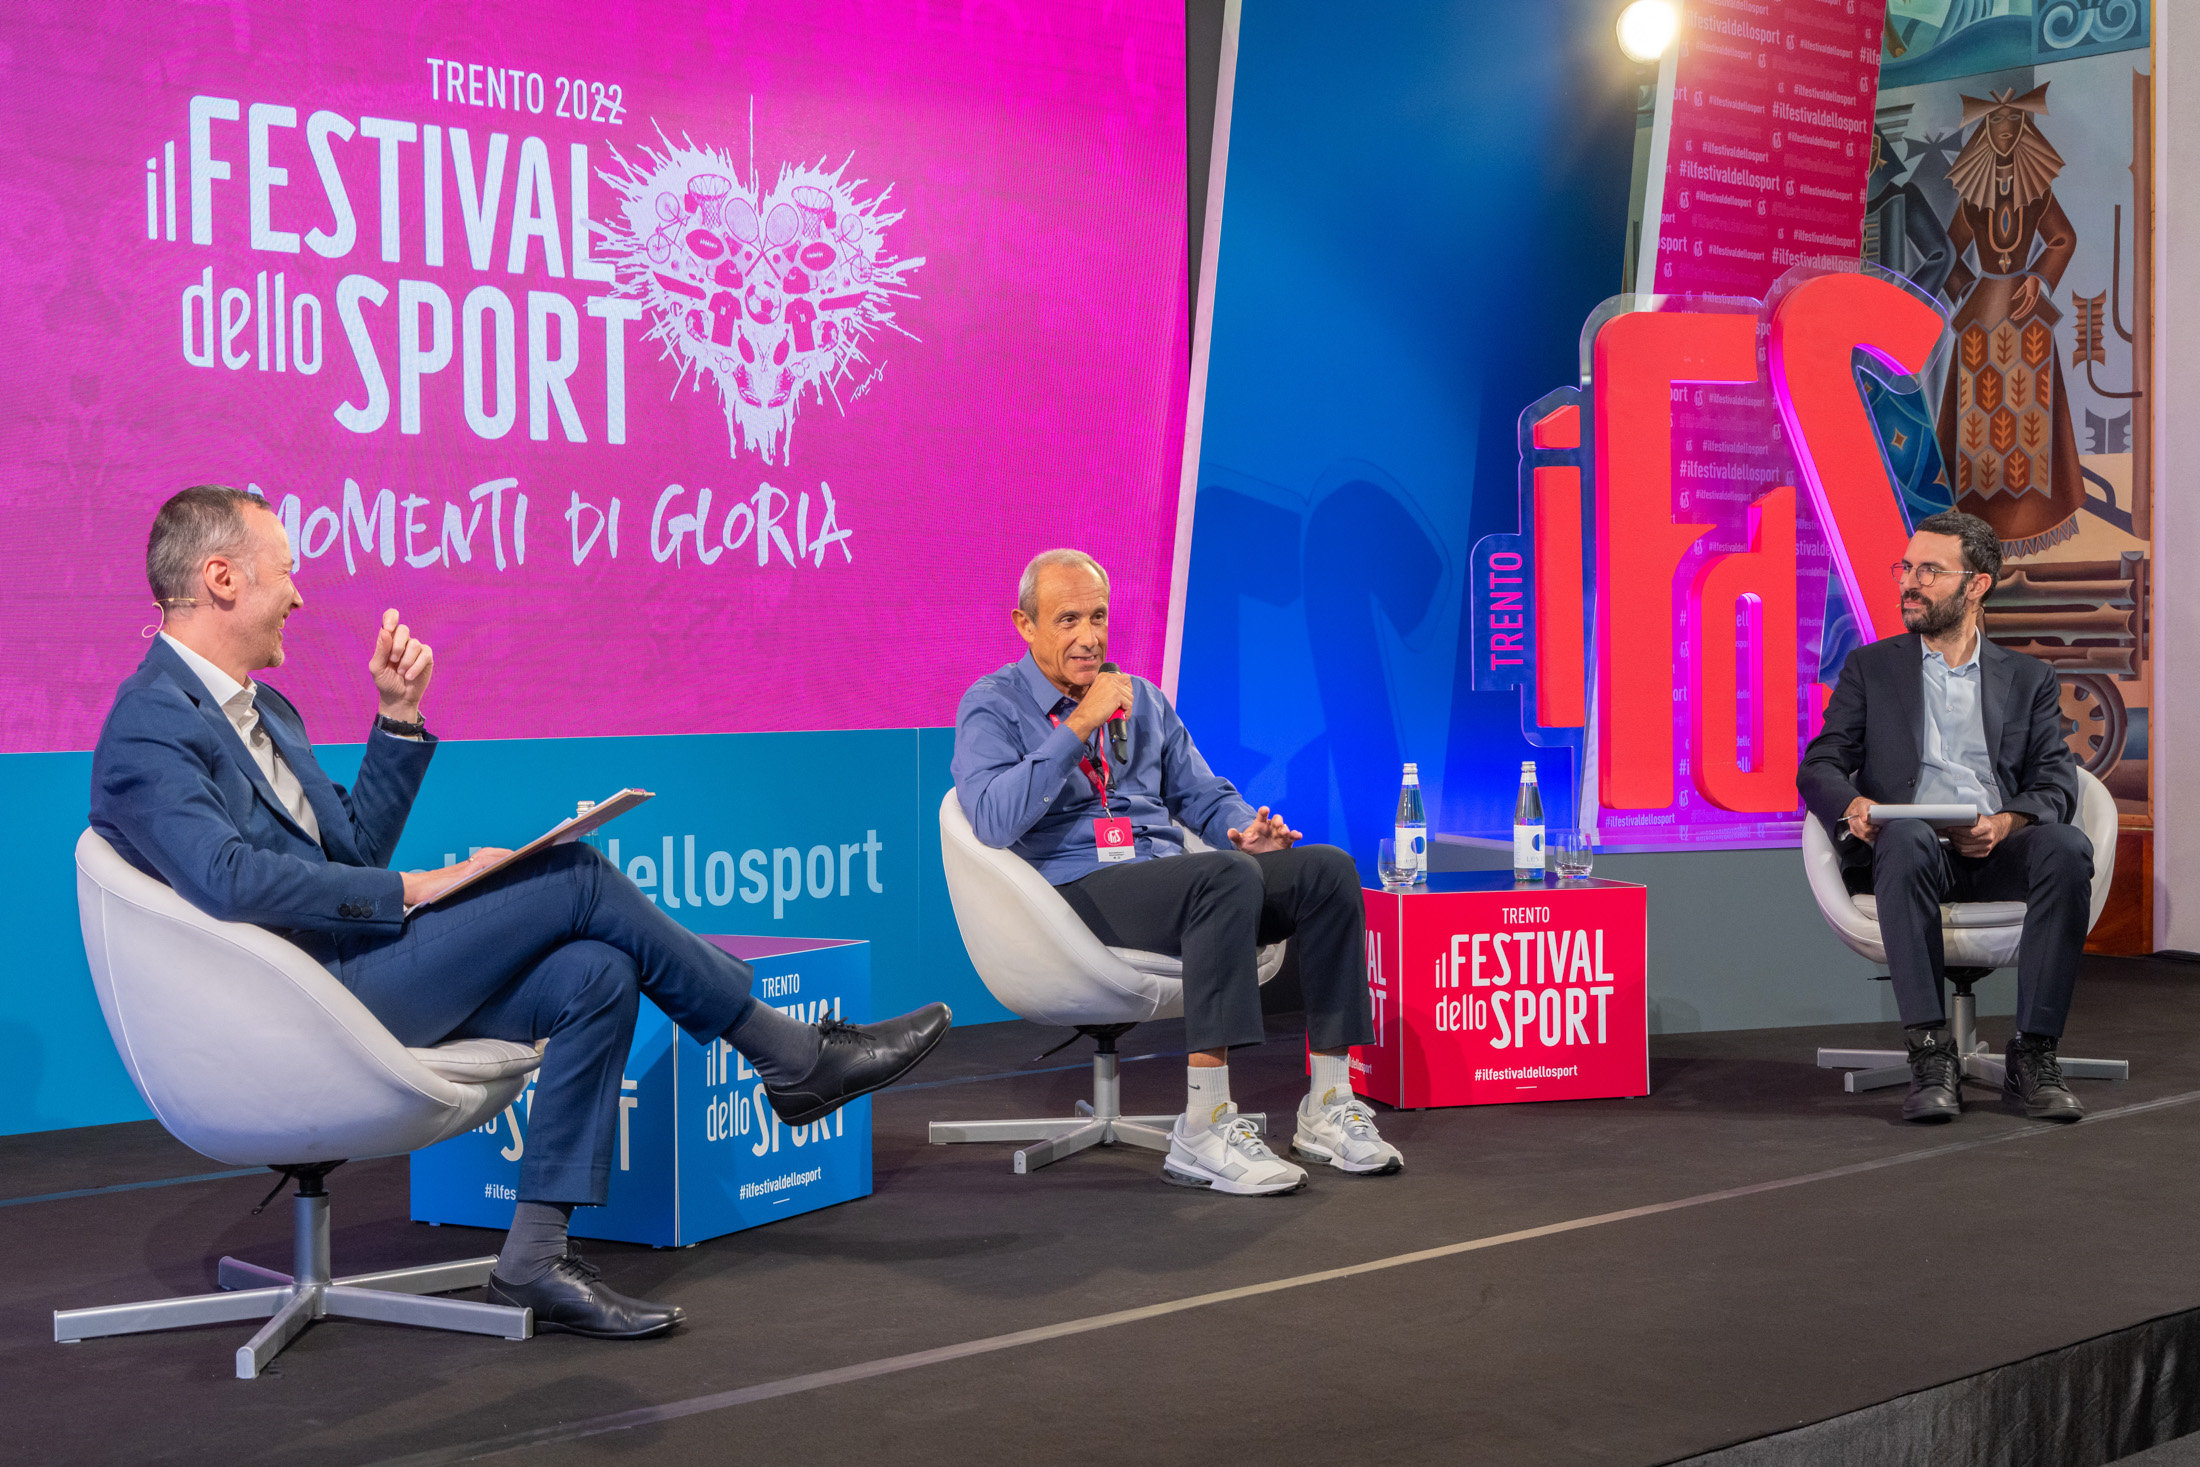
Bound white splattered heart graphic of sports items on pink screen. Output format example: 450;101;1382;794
598;134;924;464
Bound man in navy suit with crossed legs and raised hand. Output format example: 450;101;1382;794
92;486;948;1339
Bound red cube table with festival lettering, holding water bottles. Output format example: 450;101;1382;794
1351;871;1650;1108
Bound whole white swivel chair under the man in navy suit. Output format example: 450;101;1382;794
53;831;541;1379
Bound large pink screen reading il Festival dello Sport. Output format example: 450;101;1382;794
0;0;1186;752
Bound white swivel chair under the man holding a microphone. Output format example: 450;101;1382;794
931;790;1283;1177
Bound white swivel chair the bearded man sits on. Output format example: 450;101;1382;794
1802;770;2132;1093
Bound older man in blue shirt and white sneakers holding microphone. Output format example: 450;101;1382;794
955;550;1404;1196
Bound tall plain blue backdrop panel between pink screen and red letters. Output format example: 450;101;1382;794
1177;0;1635;871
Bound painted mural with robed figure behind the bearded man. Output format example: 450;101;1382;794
1863;0;2154;829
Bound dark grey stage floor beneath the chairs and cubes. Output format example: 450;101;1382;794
0;959;2200;1467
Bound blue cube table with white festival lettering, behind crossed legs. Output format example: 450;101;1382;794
411;937;871;1247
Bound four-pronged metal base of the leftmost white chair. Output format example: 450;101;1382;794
53;1177;535;1381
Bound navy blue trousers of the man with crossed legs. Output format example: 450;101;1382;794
337;842;752;1207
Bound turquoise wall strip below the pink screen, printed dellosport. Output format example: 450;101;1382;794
0;728;1012;1135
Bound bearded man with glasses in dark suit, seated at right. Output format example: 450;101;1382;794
1795;510;2092;1122
